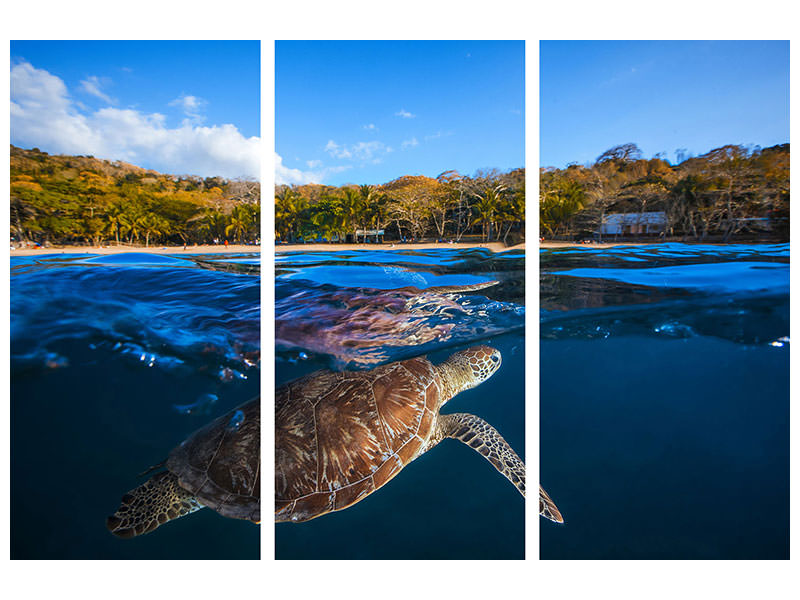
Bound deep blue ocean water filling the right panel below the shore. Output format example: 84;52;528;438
540;244;790;559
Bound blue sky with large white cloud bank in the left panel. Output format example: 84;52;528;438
11;41;261;178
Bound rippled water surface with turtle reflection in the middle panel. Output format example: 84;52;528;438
275;249;524;369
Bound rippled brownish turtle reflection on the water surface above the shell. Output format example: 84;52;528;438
275;281;498;366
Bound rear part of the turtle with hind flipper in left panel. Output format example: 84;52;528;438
106;398;261;538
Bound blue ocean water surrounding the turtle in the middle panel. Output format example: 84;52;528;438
275;249;525;559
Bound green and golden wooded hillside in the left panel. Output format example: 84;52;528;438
10;145;261;247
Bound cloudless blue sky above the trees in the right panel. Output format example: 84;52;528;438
539;41;789;168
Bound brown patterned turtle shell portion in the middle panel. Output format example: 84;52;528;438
275;358;442;522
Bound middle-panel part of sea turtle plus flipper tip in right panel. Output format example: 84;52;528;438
275;346;558;522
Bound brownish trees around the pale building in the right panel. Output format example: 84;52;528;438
539;144;789;241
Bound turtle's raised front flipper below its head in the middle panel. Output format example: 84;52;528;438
435;413;525;496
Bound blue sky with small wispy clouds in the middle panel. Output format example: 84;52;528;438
275;41;525;185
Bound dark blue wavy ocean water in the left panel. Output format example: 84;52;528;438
11;253;260;559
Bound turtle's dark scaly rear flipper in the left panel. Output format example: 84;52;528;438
106;471;203;538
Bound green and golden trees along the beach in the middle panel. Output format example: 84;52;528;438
275;169;525;243
